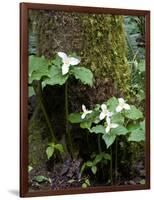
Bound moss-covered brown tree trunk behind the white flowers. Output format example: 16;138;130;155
29;10;130;167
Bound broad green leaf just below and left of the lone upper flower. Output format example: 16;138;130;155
43;66;68;85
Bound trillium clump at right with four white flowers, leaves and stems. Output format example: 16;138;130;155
69;97;145;184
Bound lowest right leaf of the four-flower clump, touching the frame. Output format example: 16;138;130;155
128;129;145;142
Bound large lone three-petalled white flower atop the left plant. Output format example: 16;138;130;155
58;52;80;75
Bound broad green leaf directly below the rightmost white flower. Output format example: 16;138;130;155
124;106;143;120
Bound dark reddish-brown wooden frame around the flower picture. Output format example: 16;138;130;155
20;3;150;197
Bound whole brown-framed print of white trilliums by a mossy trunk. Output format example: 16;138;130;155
20;3;150;197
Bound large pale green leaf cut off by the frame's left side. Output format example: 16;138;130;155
29;55;49;76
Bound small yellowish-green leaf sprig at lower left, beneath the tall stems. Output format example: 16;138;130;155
46;143;64;160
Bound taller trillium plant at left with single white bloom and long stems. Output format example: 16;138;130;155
29;52;93;157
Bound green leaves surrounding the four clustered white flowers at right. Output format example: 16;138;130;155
69;97;145;149
